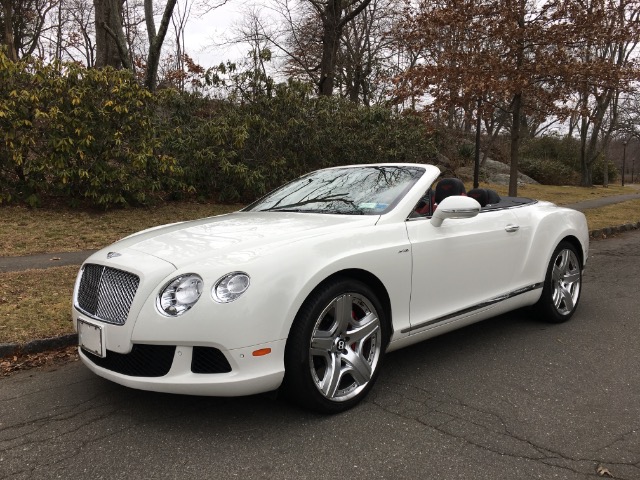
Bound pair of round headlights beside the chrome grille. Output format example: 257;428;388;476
157;272;249;317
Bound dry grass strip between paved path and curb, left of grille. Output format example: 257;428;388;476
0;266;78;343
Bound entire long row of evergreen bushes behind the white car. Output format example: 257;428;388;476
0;53;435;208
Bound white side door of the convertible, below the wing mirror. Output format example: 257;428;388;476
406;209;528;331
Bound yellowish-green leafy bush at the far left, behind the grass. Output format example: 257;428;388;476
0;52;180;208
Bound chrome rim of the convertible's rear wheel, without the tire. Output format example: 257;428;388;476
551;249;582;315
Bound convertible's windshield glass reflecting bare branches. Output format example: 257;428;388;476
244;166;424;215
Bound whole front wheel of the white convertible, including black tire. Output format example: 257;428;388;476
283;278;389;413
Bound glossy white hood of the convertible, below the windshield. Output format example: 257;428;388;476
108;212;380;268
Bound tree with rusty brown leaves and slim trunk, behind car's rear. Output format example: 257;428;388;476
399;0;639;195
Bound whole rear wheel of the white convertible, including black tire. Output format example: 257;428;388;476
534;241;582;323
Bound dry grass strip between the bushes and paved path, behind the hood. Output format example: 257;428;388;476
0;203;241;256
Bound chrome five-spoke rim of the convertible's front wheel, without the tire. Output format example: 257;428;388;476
309;293;382;402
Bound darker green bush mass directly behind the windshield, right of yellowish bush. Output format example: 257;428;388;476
156;82;434;201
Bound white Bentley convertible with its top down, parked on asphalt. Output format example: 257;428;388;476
73;164;588;412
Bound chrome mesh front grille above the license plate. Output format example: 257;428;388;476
75;263;140;325
